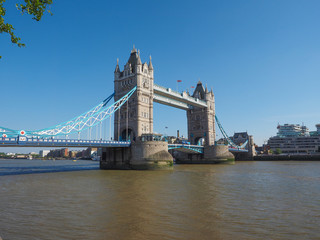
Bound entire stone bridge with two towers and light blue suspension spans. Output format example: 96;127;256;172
0;48;254;169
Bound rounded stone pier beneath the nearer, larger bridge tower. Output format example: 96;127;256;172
100;141;173;170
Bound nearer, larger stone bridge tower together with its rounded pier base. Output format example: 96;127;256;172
100;47;173;170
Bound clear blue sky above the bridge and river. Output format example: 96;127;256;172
0;0;320;152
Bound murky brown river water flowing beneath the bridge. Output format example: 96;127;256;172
0;160;320;240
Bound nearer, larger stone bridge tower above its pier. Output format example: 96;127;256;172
114;47;154;140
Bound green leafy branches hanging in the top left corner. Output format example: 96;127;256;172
0;0;53;58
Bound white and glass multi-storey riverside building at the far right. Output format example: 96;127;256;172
268;124;320;154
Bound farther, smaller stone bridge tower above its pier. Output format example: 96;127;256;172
187;81;216;146
